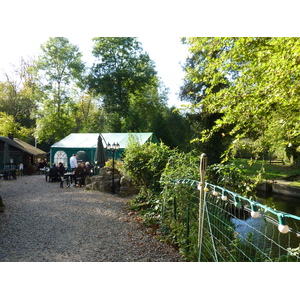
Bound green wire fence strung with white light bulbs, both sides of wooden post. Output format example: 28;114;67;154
161;179;300;262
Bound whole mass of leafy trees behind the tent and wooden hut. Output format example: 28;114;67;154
0;37;189;151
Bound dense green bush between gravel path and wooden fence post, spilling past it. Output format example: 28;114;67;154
123;141;255;261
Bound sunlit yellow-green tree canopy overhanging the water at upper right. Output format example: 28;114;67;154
184;37;300;162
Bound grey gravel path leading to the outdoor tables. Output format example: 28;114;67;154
0;175;181;262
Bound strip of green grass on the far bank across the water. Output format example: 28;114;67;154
233;158;300;186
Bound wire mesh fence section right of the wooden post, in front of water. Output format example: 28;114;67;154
199;183;300;262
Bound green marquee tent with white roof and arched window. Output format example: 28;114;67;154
50;132;158;168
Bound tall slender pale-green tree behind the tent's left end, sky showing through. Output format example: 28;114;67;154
35;37;85;143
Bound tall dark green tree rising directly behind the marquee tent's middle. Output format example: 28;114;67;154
88;37;156;131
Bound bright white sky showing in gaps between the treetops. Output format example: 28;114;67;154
0;35;188;107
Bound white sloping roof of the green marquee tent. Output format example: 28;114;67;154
51;132;156;149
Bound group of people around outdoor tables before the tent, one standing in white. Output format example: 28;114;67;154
49;154;94;186
